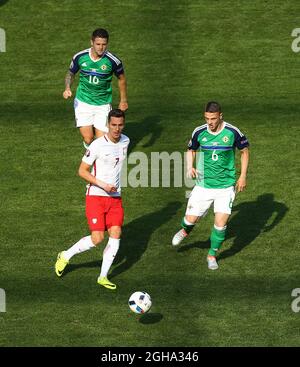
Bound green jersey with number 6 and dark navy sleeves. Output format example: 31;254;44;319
188;121;249;189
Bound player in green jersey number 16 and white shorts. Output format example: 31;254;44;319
63;28;128;148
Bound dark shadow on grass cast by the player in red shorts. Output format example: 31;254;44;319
63;201;182;279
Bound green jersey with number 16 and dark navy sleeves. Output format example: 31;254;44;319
70;48;124;106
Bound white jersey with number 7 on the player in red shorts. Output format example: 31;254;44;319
82;134;130;196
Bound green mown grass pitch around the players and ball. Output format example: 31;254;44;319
0;0;300;347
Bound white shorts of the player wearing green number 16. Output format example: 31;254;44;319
74;98;111;133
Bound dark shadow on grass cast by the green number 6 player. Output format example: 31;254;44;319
178;193;288;260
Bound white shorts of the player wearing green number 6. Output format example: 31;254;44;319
185;186;235;217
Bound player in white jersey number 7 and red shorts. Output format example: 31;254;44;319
55;109;129;289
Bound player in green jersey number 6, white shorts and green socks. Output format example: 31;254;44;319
172;102;249;270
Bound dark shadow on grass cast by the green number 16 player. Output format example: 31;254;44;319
124;115;163;153
